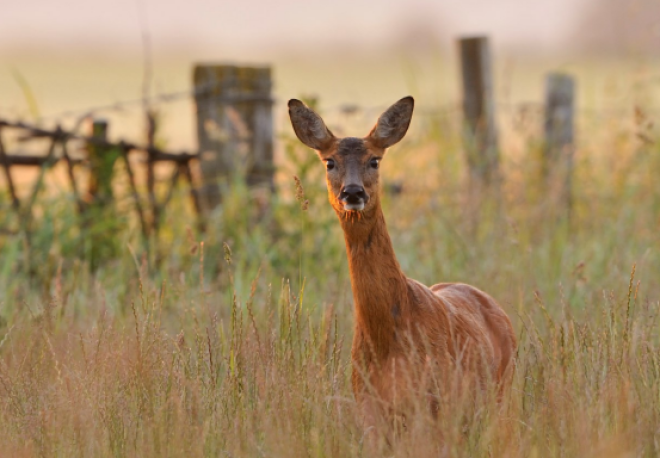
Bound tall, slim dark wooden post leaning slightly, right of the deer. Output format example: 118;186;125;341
459;37;499;184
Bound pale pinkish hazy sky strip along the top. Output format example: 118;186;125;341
0;0;597;55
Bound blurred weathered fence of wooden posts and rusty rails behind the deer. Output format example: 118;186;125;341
0;37;575;254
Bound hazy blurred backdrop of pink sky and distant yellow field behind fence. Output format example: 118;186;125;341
0;0;660;148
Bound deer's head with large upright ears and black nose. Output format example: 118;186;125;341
289;97;414;214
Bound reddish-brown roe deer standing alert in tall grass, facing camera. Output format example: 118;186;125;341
289;97;517;424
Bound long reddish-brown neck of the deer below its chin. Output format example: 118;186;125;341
339;205;408;357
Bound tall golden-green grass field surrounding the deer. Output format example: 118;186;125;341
0;52;660;457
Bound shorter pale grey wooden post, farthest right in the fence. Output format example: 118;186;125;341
543;73;575;214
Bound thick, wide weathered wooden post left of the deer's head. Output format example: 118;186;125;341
193;65;274;210
